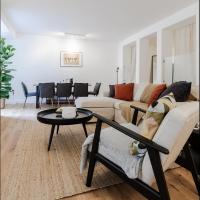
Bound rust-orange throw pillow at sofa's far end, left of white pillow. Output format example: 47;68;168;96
115;83;134;101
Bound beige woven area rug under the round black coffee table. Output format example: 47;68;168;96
1;118;122;200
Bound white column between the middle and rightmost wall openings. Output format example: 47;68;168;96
156;30;163;83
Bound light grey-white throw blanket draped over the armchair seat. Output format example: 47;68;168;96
80;124;143;179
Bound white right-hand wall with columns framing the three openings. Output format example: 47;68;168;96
119;2;199;84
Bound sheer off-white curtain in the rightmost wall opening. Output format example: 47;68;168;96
164;24;196;83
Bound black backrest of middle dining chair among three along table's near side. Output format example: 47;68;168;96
56;83;72;97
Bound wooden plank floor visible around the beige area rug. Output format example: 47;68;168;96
1;104;200;200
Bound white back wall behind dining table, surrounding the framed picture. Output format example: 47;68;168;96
7;35;118;102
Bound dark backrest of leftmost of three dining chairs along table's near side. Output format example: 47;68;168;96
39;83;55;98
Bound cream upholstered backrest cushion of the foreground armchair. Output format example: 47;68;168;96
142;101;199;184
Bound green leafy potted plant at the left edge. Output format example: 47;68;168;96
0;38;15;109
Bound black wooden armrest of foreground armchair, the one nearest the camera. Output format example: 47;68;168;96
93;113;169;154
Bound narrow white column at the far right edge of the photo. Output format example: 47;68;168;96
195;10;199;85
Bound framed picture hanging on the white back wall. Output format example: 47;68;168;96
60;51;82;67
